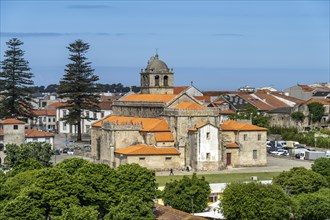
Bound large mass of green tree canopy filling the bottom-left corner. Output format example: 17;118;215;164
0;158;157;220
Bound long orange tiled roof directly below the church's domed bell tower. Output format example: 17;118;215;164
120;94;176;103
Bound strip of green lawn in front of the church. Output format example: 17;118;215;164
156;172;281;186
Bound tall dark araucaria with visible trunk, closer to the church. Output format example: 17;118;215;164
58;40;99;141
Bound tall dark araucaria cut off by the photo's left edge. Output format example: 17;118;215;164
0;38;33;119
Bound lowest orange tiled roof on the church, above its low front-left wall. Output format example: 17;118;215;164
115;144;180;155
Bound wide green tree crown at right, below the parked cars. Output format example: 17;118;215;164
273;167;328;195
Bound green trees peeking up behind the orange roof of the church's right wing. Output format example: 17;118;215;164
229;105;270;128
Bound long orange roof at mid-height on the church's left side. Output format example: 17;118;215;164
92;116;170;132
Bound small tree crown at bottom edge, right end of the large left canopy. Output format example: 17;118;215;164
104;195;155;220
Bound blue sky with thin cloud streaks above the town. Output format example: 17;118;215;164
0;0;330;90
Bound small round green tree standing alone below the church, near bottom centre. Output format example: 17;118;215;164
163;173;211;213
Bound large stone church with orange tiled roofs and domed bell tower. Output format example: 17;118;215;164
91;54;267;170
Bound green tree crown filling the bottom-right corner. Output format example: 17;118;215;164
293;188;330;220
